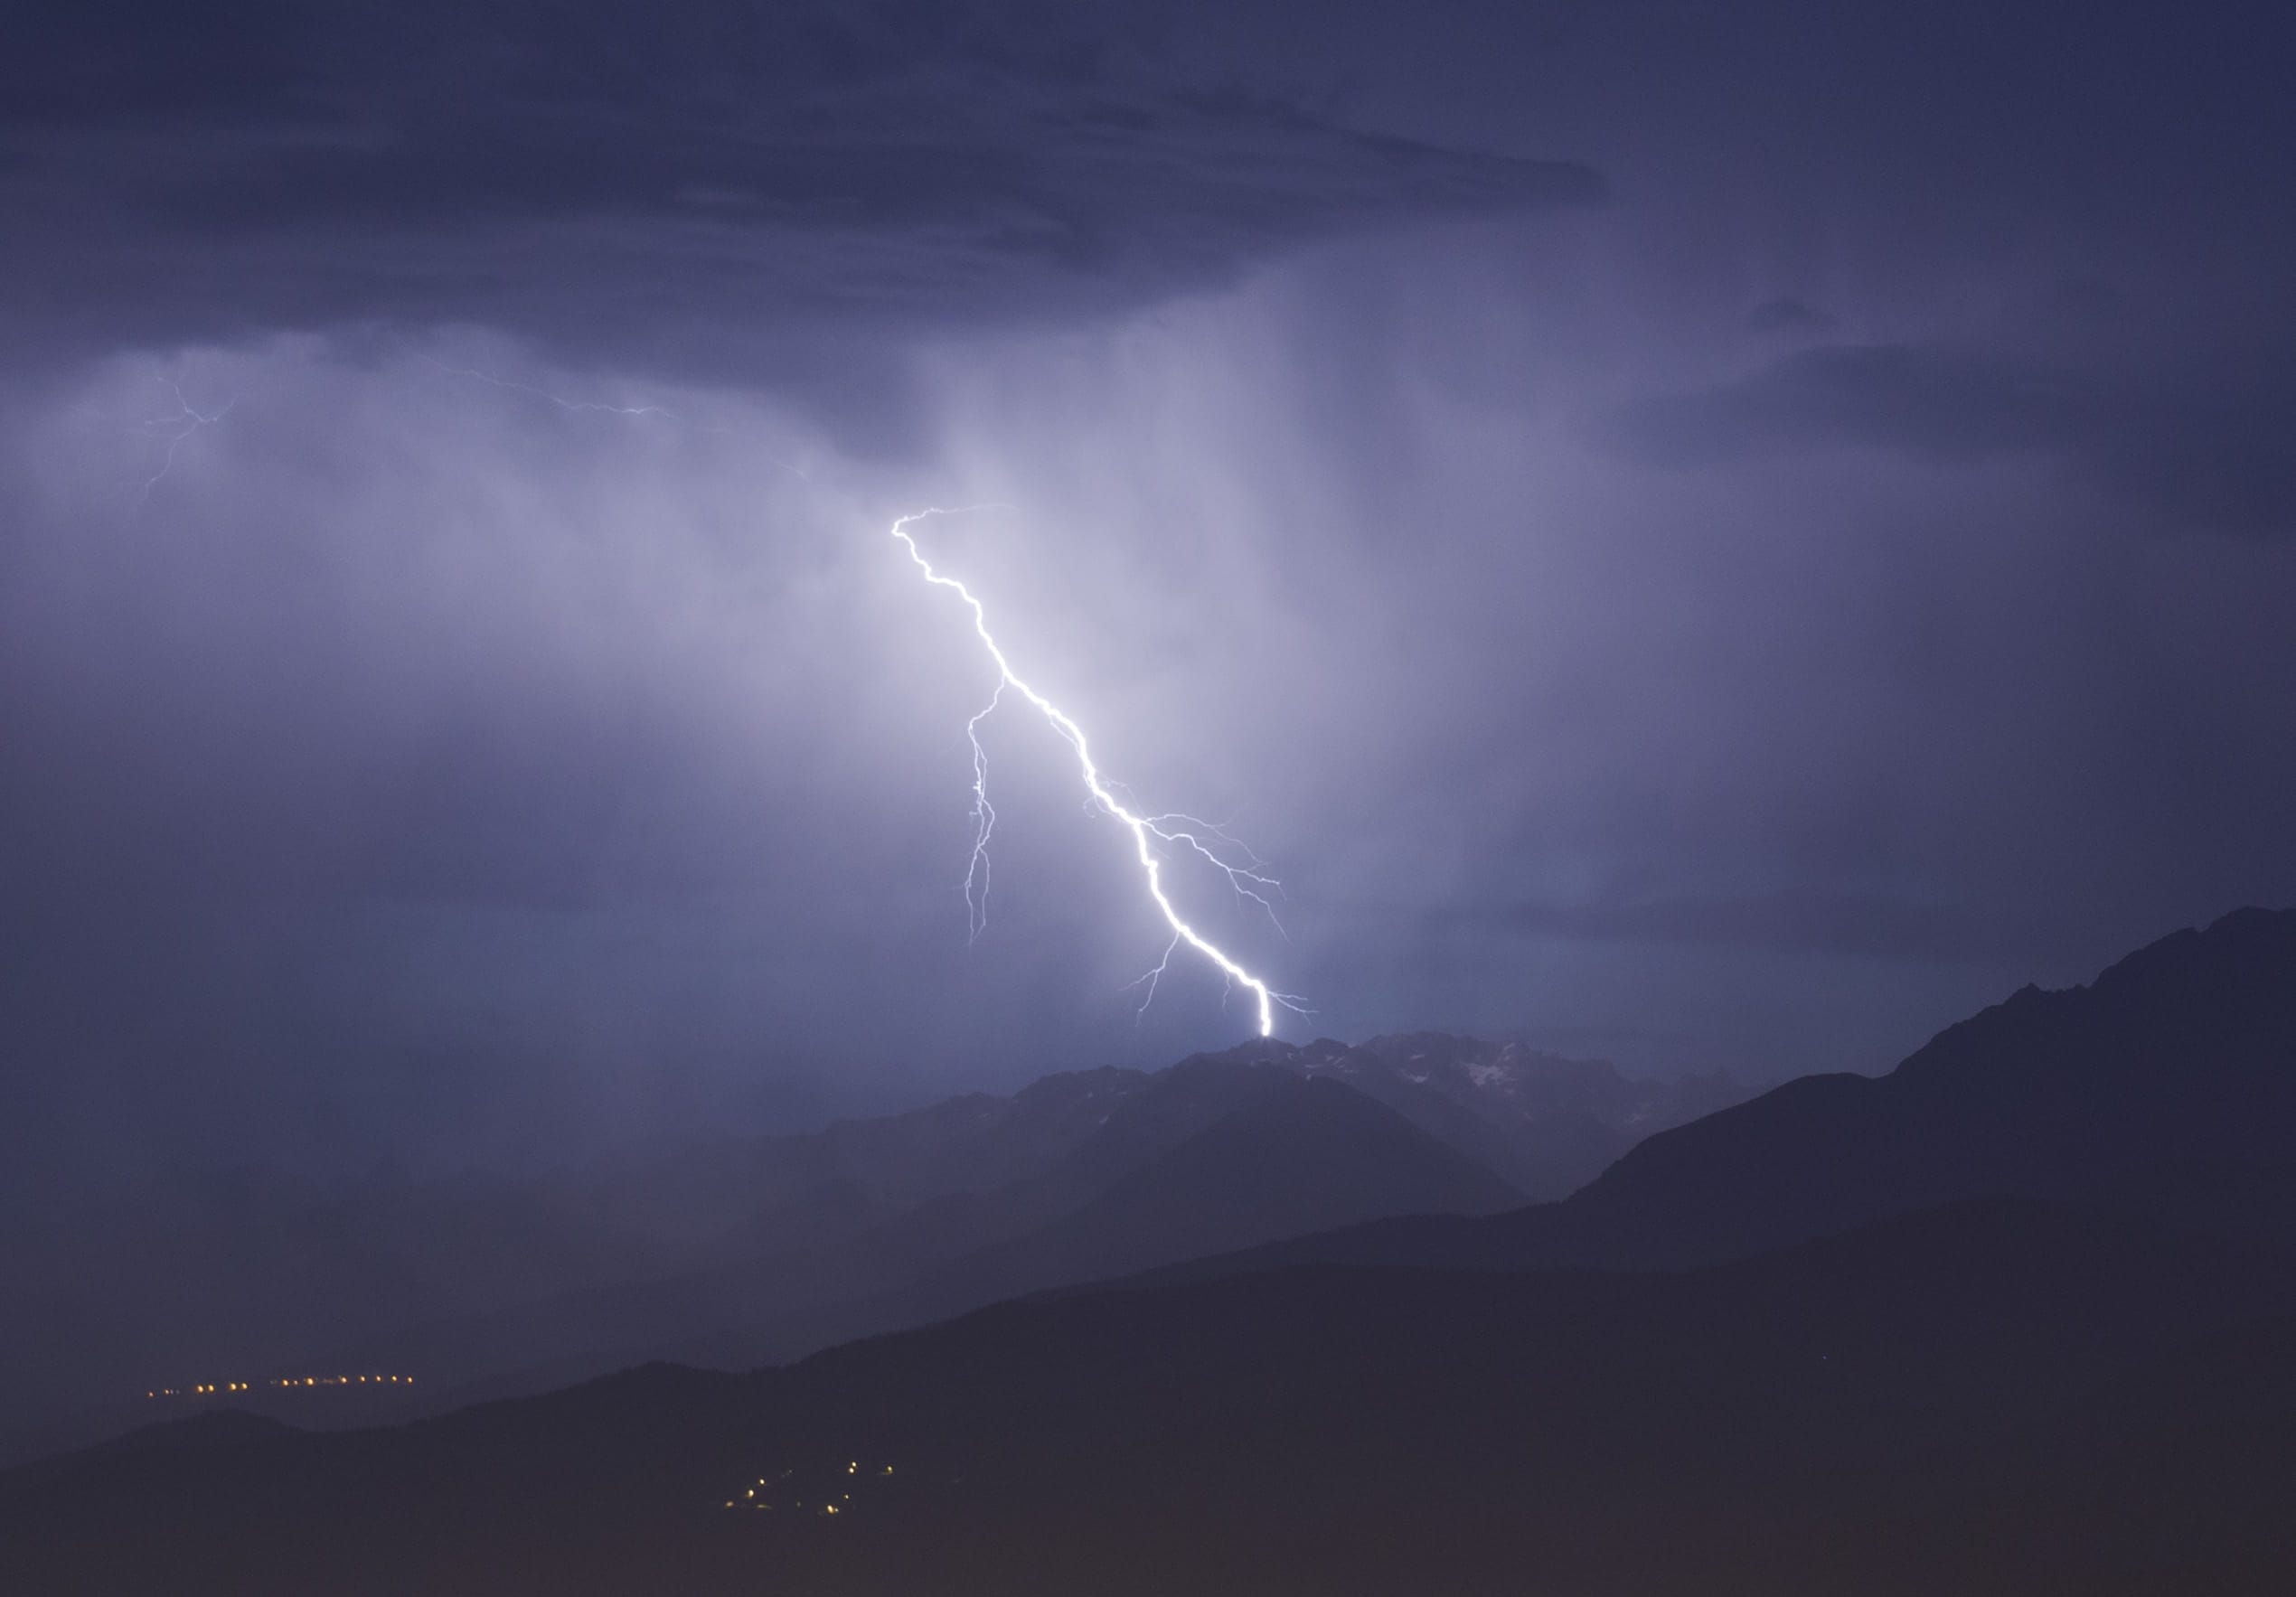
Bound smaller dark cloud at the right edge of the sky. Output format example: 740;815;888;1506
1612;344;2296;537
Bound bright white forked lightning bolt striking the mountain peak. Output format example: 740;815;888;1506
893;505;1306;1038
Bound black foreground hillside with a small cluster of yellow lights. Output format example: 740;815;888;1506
0;1200;2296;1597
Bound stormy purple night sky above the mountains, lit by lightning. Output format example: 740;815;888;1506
0;0;2296;1191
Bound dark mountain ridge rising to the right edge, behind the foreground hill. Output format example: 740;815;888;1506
1157;908;2296;1269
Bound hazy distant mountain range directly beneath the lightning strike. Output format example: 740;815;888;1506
0;1035;1738;1460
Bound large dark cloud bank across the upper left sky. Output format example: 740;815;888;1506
0;5;1600;365
